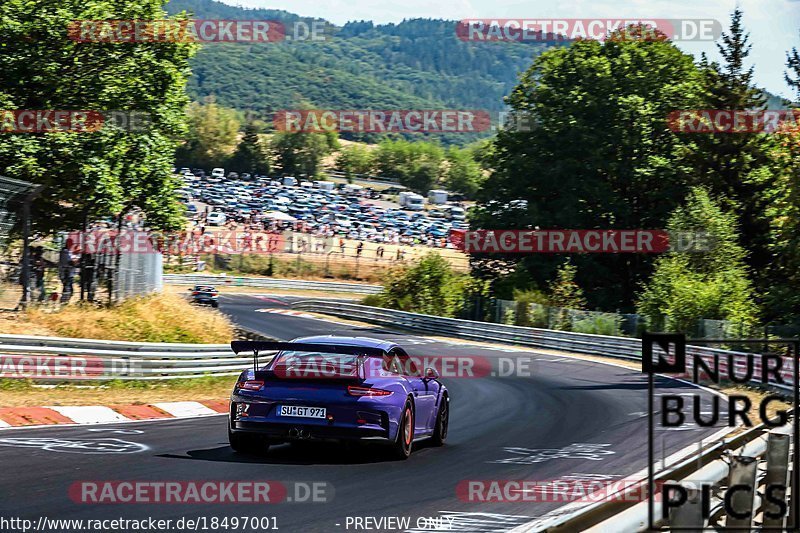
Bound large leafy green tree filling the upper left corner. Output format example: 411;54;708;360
0;0;197;232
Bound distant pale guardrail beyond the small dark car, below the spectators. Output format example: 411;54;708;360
164;274;383;294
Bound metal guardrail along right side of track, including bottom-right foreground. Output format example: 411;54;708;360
292;300;792;533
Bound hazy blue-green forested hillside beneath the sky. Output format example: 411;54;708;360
167;0;547;120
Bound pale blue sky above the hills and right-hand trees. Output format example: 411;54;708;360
222;0;800;99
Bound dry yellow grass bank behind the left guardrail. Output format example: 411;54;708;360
0;293;233;343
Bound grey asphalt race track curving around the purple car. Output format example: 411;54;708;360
0;295;719;532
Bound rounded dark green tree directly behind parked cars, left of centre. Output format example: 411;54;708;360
272;132;338;177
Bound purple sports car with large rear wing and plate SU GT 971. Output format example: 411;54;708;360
228;336;450;459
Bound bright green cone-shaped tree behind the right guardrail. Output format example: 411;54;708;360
638;188;757;335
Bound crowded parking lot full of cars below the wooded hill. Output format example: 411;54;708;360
180;169;467;251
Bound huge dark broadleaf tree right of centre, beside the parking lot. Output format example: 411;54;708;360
470;31;703;309
